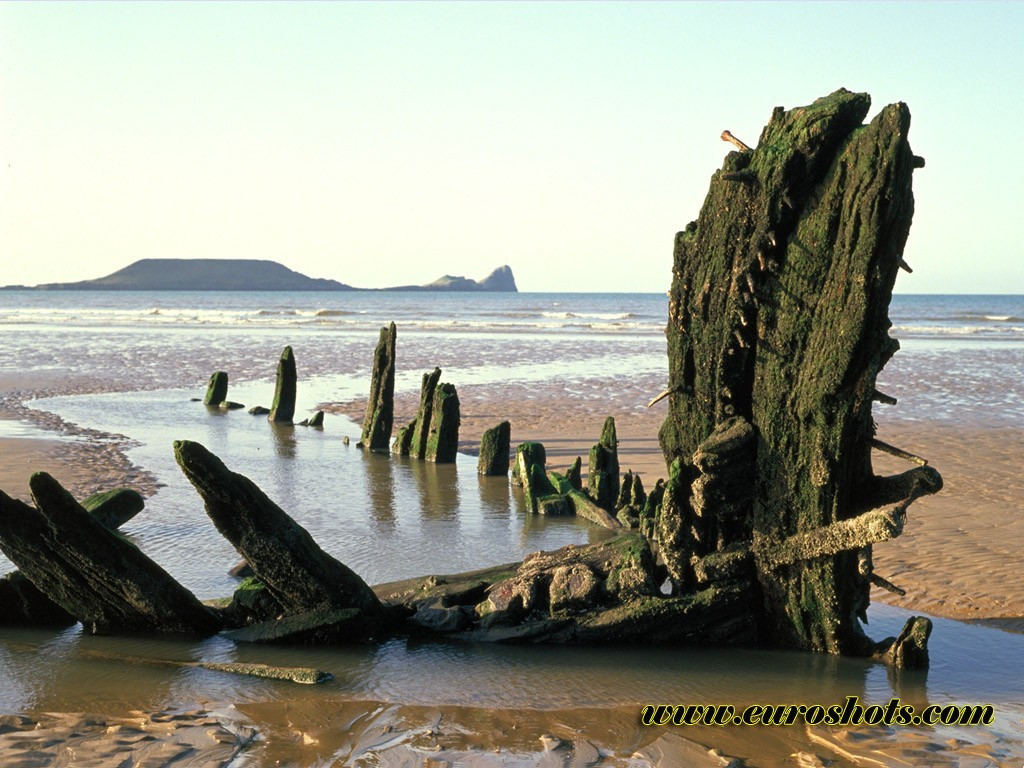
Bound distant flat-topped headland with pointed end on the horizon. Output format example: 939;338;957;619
4;259;518;293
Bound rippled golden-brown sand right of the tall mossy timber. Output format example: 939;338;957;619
873;422;1024;632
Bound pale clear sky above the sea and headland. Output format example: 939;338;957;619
0;2;1024;293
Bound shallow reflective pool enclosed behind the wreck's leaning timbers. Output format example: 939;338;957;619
14;380;607;599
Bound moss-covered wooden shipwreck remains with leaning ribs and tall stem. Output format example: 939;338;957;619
0;90;942;667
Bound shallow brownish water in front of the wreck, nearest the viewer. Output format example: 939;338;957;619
0;606;1024;766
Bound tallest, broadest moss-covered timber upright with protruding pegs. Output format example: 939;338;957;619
653;90;941;665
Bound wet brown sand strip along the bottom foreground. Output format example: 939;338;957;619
0;700;1021;768
